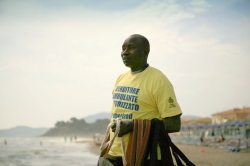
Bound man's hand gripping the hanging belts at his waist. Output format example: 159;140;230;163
111;121;134;137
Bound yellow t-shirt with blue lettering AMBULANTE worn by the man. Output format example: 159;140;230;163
109;66;182;156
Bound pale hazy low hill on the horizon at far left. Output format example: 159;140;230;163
0;126;49;137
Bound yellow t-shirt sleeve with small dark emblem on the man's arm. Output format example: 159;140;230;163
154;83;182;118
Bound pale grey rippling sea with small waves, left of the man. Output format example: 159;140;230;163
0;137;98;166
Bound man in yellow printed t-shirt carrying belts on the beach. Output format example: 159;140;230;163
107;34;182;166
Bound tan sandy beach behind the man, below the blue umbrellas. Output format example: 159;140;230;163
88;142;250;166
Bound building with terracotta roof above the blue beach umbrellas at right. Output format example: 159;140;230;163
212;107;250;124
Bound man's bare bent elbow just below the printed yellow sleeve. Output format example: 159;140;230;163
163;114;181;133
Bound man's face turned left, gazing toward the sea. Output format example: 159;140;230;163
121;37;147;71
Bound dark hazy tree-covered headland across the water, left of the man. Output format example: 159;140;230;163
43;118;109;136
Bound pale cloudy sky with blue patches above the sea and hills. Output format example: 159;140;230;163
0;0;250;129
